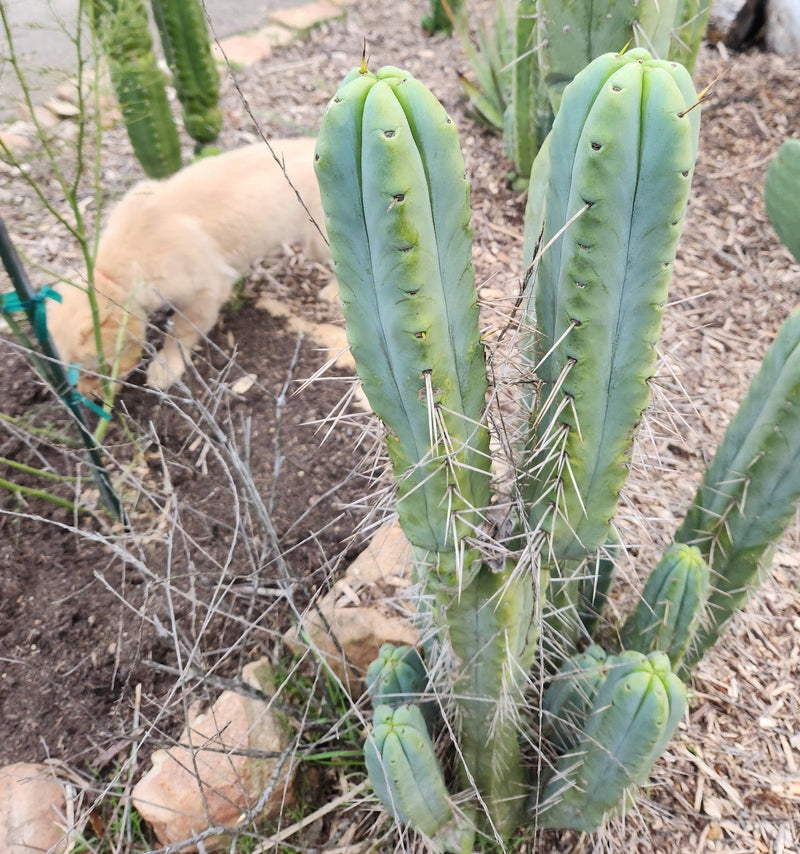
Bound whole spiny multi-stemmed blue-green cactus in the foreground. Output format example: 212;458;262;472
316;43;800;851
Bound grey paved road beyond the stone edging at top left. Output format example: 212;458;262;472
0;0;307;118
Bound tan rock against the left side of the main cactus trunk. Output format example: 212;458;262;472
286;524;419;697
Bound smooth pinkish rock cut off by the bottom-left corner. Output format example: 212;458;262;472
0;762;70;854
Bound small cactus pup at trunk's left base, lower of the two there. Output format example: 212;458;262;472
364;705;453;837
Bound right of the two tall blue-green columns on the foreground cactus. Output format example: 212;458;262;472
523;49;699;565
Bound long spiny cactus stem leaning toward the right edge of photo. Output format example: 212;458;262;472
675;311;800;670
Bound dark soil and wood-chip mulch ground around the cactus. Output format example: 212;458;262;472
0;2;800;854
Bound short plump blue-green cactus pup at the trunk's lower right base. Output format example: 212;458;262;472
532;651;686;832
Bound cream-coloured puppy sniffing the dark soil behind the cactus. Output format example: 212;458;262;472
47;138;328;394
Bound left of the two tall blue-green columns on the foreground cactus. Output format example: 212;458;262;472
316;67;490;585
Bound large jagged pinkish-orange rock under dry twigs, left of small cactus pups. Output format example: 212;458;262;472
132;659;292;851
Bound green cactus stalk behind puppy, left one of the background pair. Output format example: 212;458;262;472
89;0;181;178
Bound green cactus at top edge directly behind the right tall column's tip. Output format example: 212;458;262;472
536;0;677;112
